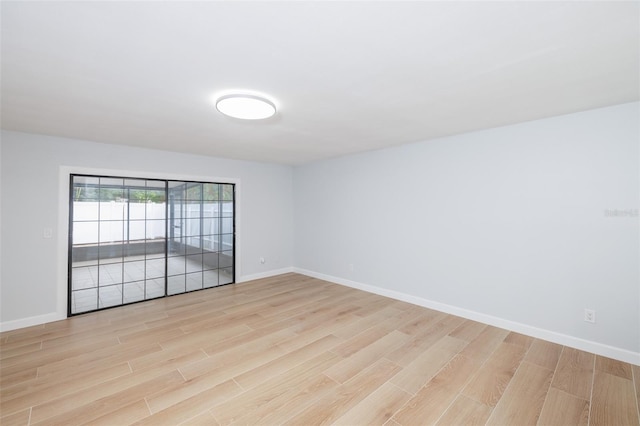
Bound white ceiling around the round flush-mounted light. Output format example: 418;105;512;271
1;1;640;164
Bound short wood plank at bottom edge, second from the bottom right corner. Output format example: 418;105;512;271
538;387;589;426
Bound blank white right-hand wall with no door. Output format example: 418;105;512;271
294;103;640;364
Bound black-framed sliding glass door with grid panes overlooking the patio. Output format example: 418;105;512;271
68;175;235;315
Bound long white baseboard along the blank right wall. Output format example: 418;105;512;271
293;268;640;365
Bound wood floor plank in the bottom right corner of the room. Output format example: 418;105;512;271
589;370;640;426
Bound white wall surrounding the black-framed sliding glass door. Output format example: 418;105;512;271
0;131;293;330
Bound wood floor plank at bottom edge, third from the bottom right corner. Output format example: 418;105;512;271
487;362;553;425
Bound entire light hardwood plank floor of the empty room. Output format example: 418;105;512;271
0;274;640;426
